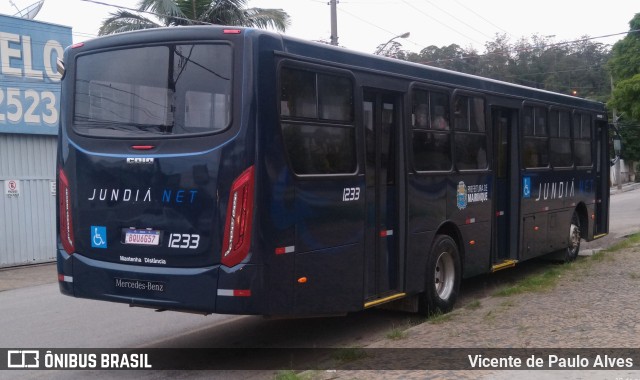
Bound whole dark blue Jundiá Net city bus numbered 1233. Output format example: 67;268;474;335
57;26;609;316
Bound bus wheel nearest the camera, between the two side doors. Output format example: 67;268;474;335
419;235;460;316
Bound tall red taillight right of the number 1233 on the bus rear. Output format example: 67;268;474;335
221;166;254;267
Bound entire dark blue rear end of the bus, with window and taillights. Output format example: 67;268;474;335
57;29;263;314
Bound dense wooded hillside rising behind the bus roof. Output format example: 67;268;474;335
406;34;611;101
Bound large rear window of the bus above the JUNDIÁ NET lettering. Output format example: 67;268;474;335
73;44;232;138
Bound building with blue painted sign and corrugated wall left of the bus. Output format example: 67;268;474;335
0;15;72;267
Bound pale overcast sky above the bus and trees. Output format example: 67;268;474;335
0;0;640;53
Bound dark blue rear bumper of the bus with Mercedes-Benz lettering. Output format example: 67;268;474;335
58;250;261;314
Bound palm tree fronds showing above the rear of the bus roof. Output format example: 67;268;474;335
98;0;289;36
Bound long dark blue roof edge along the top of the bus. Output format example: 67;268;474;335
75;25;606;112
